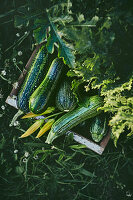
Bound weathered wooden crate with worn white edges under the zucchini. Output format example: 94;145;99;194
6;44;110;155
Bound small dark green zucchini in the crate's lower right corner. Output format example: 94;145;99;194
90;114;107;142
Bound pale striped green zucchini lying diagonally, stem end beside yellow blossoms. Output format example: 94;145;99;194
46;95;103;143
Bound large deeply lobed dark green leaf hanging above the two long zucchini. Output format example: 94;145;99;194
34;10;75;68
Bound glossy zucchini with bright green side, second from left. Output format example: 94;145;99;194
29;58;64;114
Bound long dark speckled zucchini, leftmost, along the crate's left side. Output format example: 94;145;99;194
17;45;48;112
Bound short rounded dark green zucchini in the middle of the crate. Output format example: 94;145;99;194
56;79;77;112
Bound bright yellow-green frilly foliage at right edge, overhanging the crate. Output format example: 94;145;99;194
101;77;133;145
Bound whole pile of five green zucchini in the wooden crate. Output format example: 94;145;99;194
17;45;107;143
